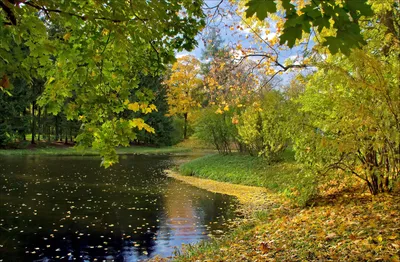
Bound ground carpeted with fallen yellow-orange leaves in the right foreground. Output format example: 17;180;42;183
170;191;400;261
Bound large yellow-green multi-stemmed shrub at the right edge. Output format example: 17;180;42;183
294;1;400;194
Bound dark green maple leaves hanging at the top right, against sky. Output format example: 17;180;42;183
246;0;374;55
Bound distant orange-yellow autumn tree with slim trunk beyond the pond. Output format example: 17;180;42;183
165;56;202;139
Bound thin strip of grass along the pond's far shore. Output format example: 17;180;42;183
0;146;190;156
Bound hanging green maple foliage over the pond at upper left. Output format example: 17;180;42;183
0;0;204;166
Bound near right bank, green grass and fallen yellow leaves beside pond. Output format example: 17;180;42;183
167;152;400;261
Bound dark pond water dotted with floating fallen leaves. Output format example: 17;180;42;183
0;155;236;261
